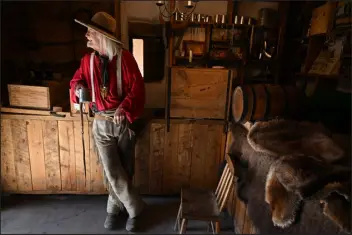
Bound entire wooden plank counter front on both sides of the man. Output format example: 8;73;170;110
1;115;226;195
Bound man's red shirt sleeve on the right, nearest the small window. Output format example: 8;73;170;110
119;50;145;123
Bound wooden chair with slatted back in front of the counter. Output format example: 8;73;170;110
174;155;234;234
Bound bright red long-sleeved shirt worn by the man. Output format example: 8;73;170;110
70;50;145;123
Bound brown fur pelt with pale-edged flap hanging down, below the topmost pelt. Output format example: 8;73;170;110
265;155;351;231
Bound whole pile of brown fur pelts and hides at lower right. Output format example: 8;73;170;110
229;120;351;234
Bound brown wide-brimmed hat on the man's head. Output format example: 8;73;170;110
75;11;122;44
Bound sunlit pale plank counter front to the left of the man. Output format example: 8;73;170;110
1;118;106;194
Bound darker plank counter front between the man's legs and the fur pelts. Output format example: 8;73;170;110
134;122;226;195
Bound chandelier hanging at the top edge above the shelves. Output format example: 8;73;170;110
155;0;199;21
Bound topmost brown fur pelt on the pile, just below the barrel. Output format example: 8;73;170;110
247;120;344;162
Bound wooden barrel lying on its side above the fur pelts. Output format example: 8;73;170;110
232;84;302;123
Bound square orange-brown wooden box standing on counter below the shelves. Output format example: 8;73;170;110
170;67;232;119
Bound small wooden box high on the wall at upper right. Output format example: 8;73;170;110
310;2;336;36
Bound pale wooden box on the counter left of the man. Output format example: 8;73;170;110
8;81;68;110
